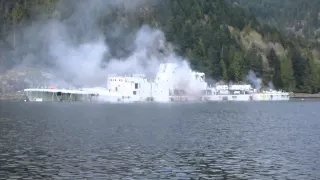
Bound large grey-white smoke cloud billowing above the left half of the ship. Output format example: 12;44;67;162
1;0;190;86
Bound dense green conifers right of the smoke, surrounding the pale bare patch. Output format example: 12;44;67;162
154;0;320;93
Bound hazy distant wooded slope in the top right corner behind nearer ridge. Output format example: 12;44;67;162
232;0;320;42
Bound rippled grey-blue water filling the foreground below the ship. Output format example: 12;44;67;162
0;101;320;179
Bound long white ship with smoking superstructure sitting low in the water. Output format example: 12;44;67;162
24;63;290;102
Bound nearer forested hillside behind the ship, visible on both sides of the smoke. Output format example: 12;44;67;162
0;0;320;93
